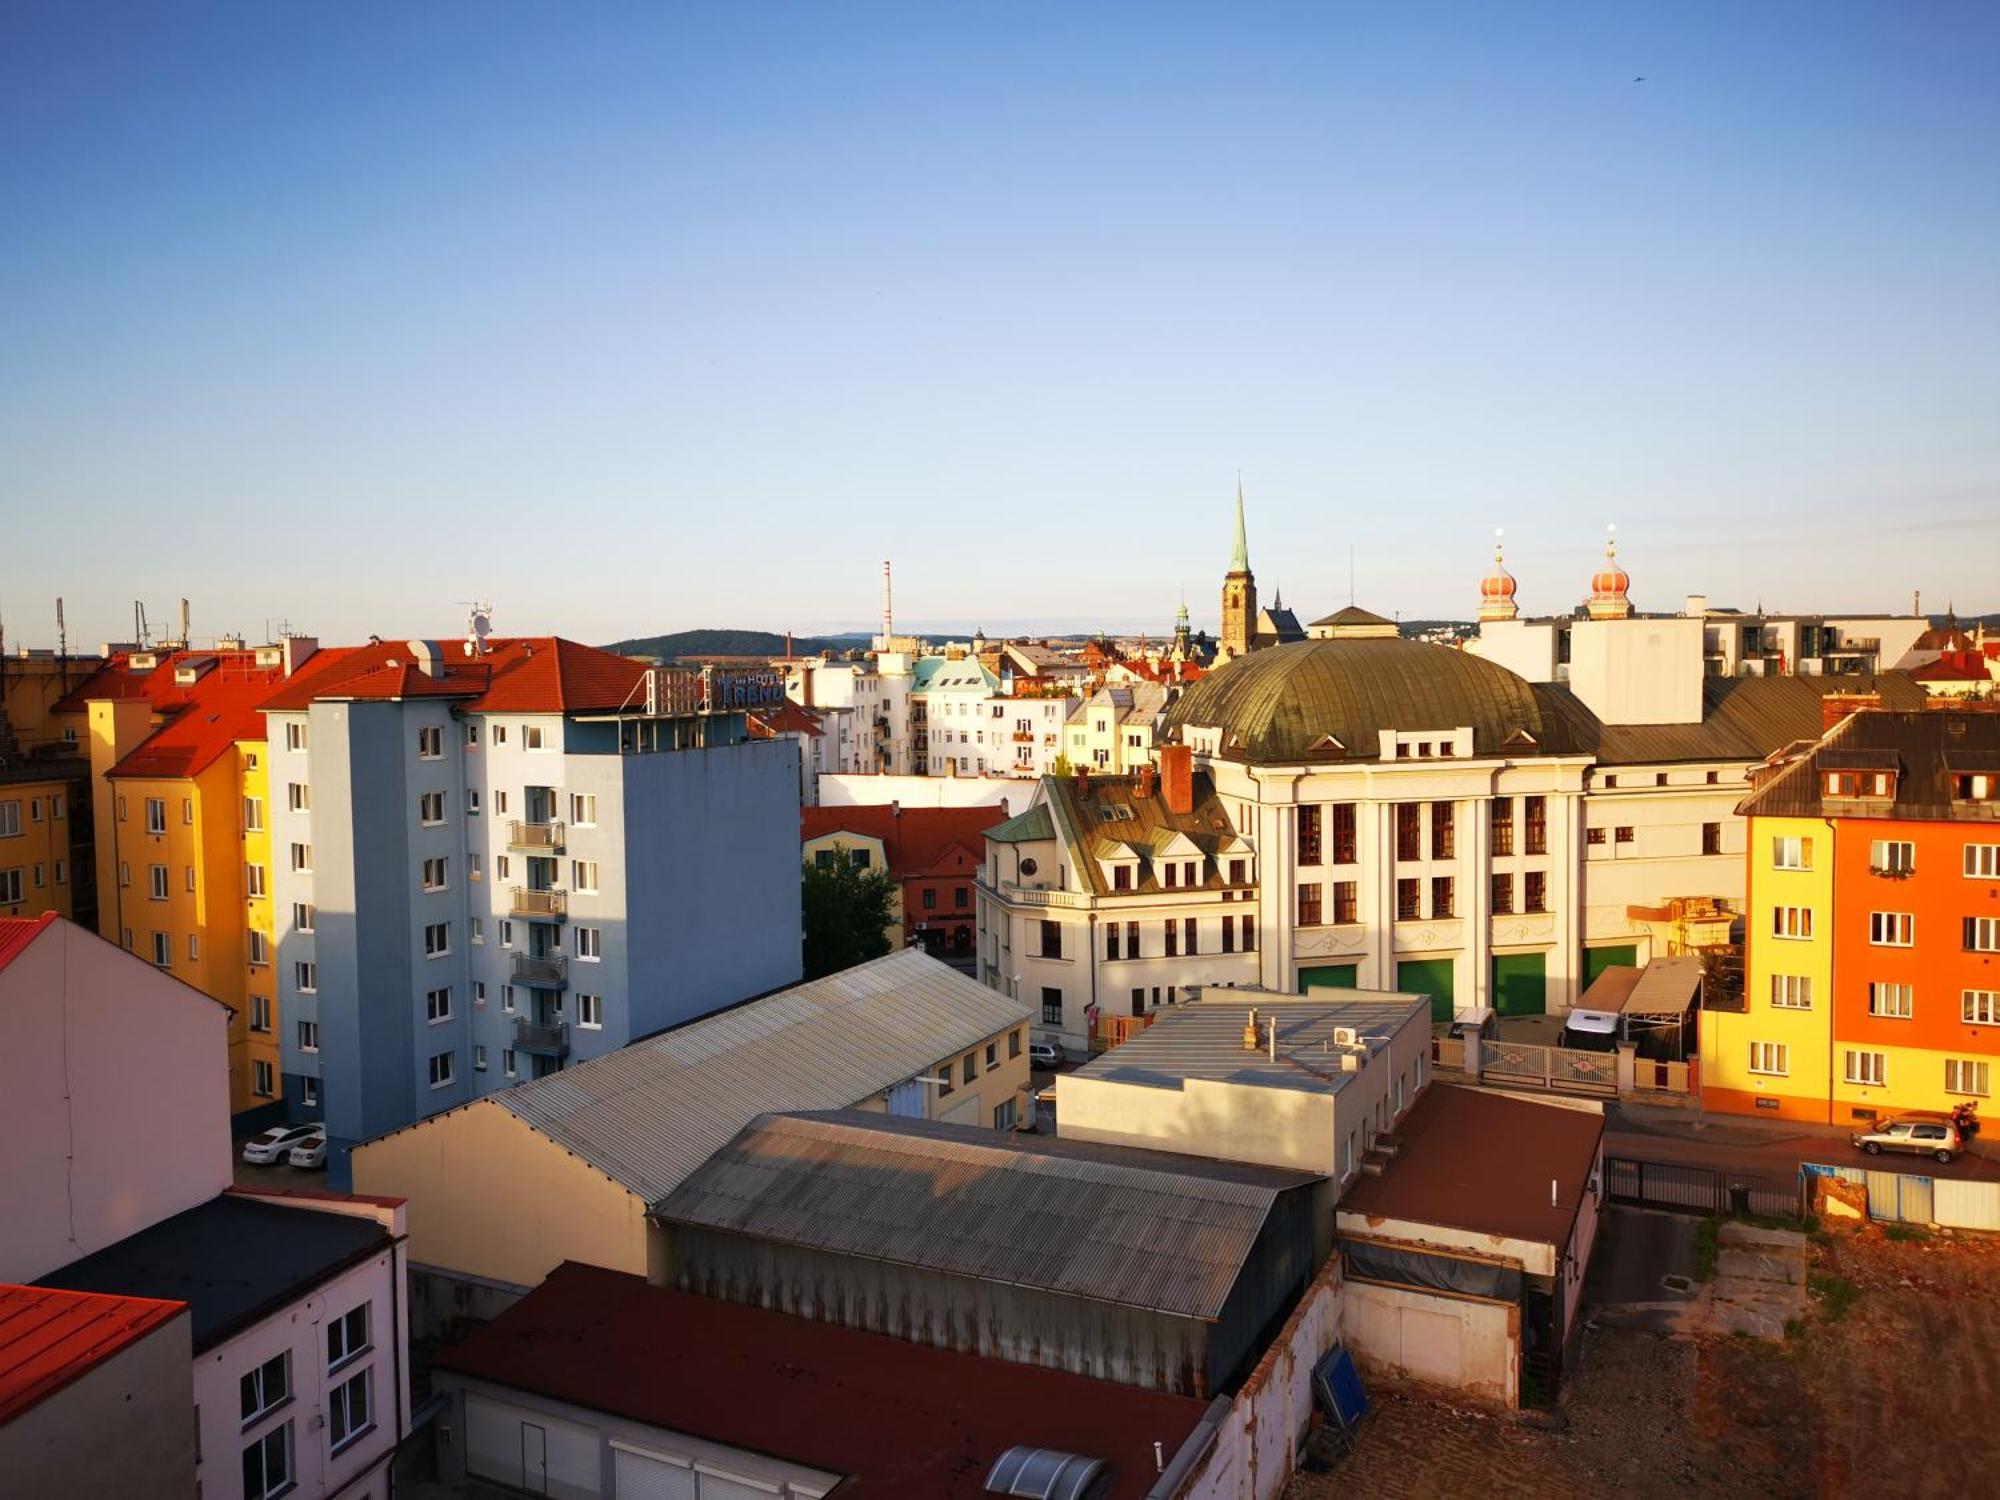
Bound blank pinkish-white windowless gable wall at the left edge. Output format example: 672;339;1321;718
0;920;232;1282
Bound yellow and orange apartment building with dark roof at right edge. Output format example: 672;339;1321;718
1702;706;2000;1124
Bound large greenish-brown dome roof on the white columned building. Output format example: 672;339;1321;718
1164;638;1580;762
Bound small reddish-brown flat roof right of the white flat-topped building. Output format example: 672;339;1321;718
1340;1084;1604;1246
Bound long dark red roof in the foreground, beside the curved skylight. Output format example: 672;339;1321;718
434;1260;1206;1500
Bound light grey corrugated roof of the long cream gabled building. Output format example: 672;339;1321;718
480;948;1030;1204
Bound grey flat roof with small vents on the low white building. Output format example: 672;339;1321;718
1058;988;1430;1094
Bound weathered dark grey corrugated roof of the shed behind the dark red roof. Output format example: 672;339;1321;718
652;1110;1320;1318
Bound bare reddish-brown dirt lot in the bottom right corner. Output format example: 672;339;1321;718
1286;1226;2000;1500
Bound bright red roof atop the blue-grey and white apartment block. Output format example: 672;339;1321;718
262;636;646;714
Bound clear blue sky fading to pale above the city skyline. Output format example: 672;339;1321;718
0;0;2000;644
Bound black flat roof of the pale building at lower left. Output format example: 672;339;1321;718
36;1192;390;1354
